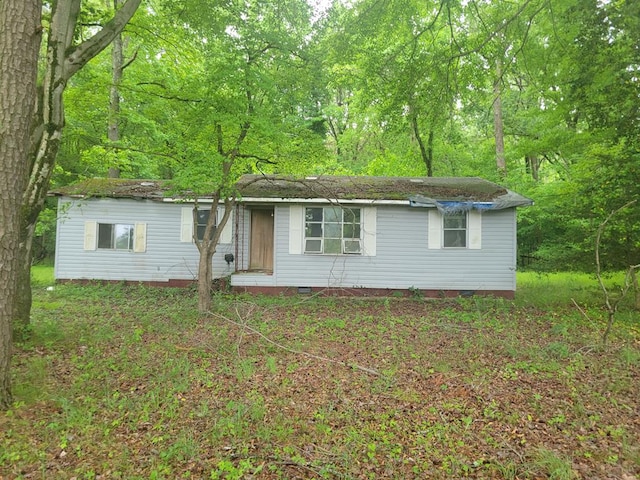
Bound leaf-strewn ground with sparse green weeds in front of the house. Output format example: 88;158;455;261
0;285;640;480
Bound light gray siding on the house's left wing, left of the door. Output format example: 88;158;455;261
55;198;235;282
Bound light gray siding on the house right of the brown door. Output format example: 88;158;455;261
232;205;516;291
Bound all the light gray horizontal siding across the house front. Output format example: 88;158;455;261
55;198;516;291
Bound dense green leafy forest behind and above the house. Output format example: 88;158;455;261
36;0;640;271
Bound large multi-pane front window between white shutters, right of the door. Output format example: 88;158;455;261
304;207;362;255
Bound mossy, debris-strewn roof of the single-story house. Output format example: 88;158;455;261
51;175;532;208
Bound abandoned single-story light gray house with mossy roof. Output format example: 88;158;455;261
52;175;532;298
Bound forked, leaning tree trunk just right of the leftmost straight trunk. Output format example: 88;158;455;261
14;0;141;330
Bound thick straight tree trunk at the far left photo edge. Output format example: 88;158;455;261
0;0;42;410
